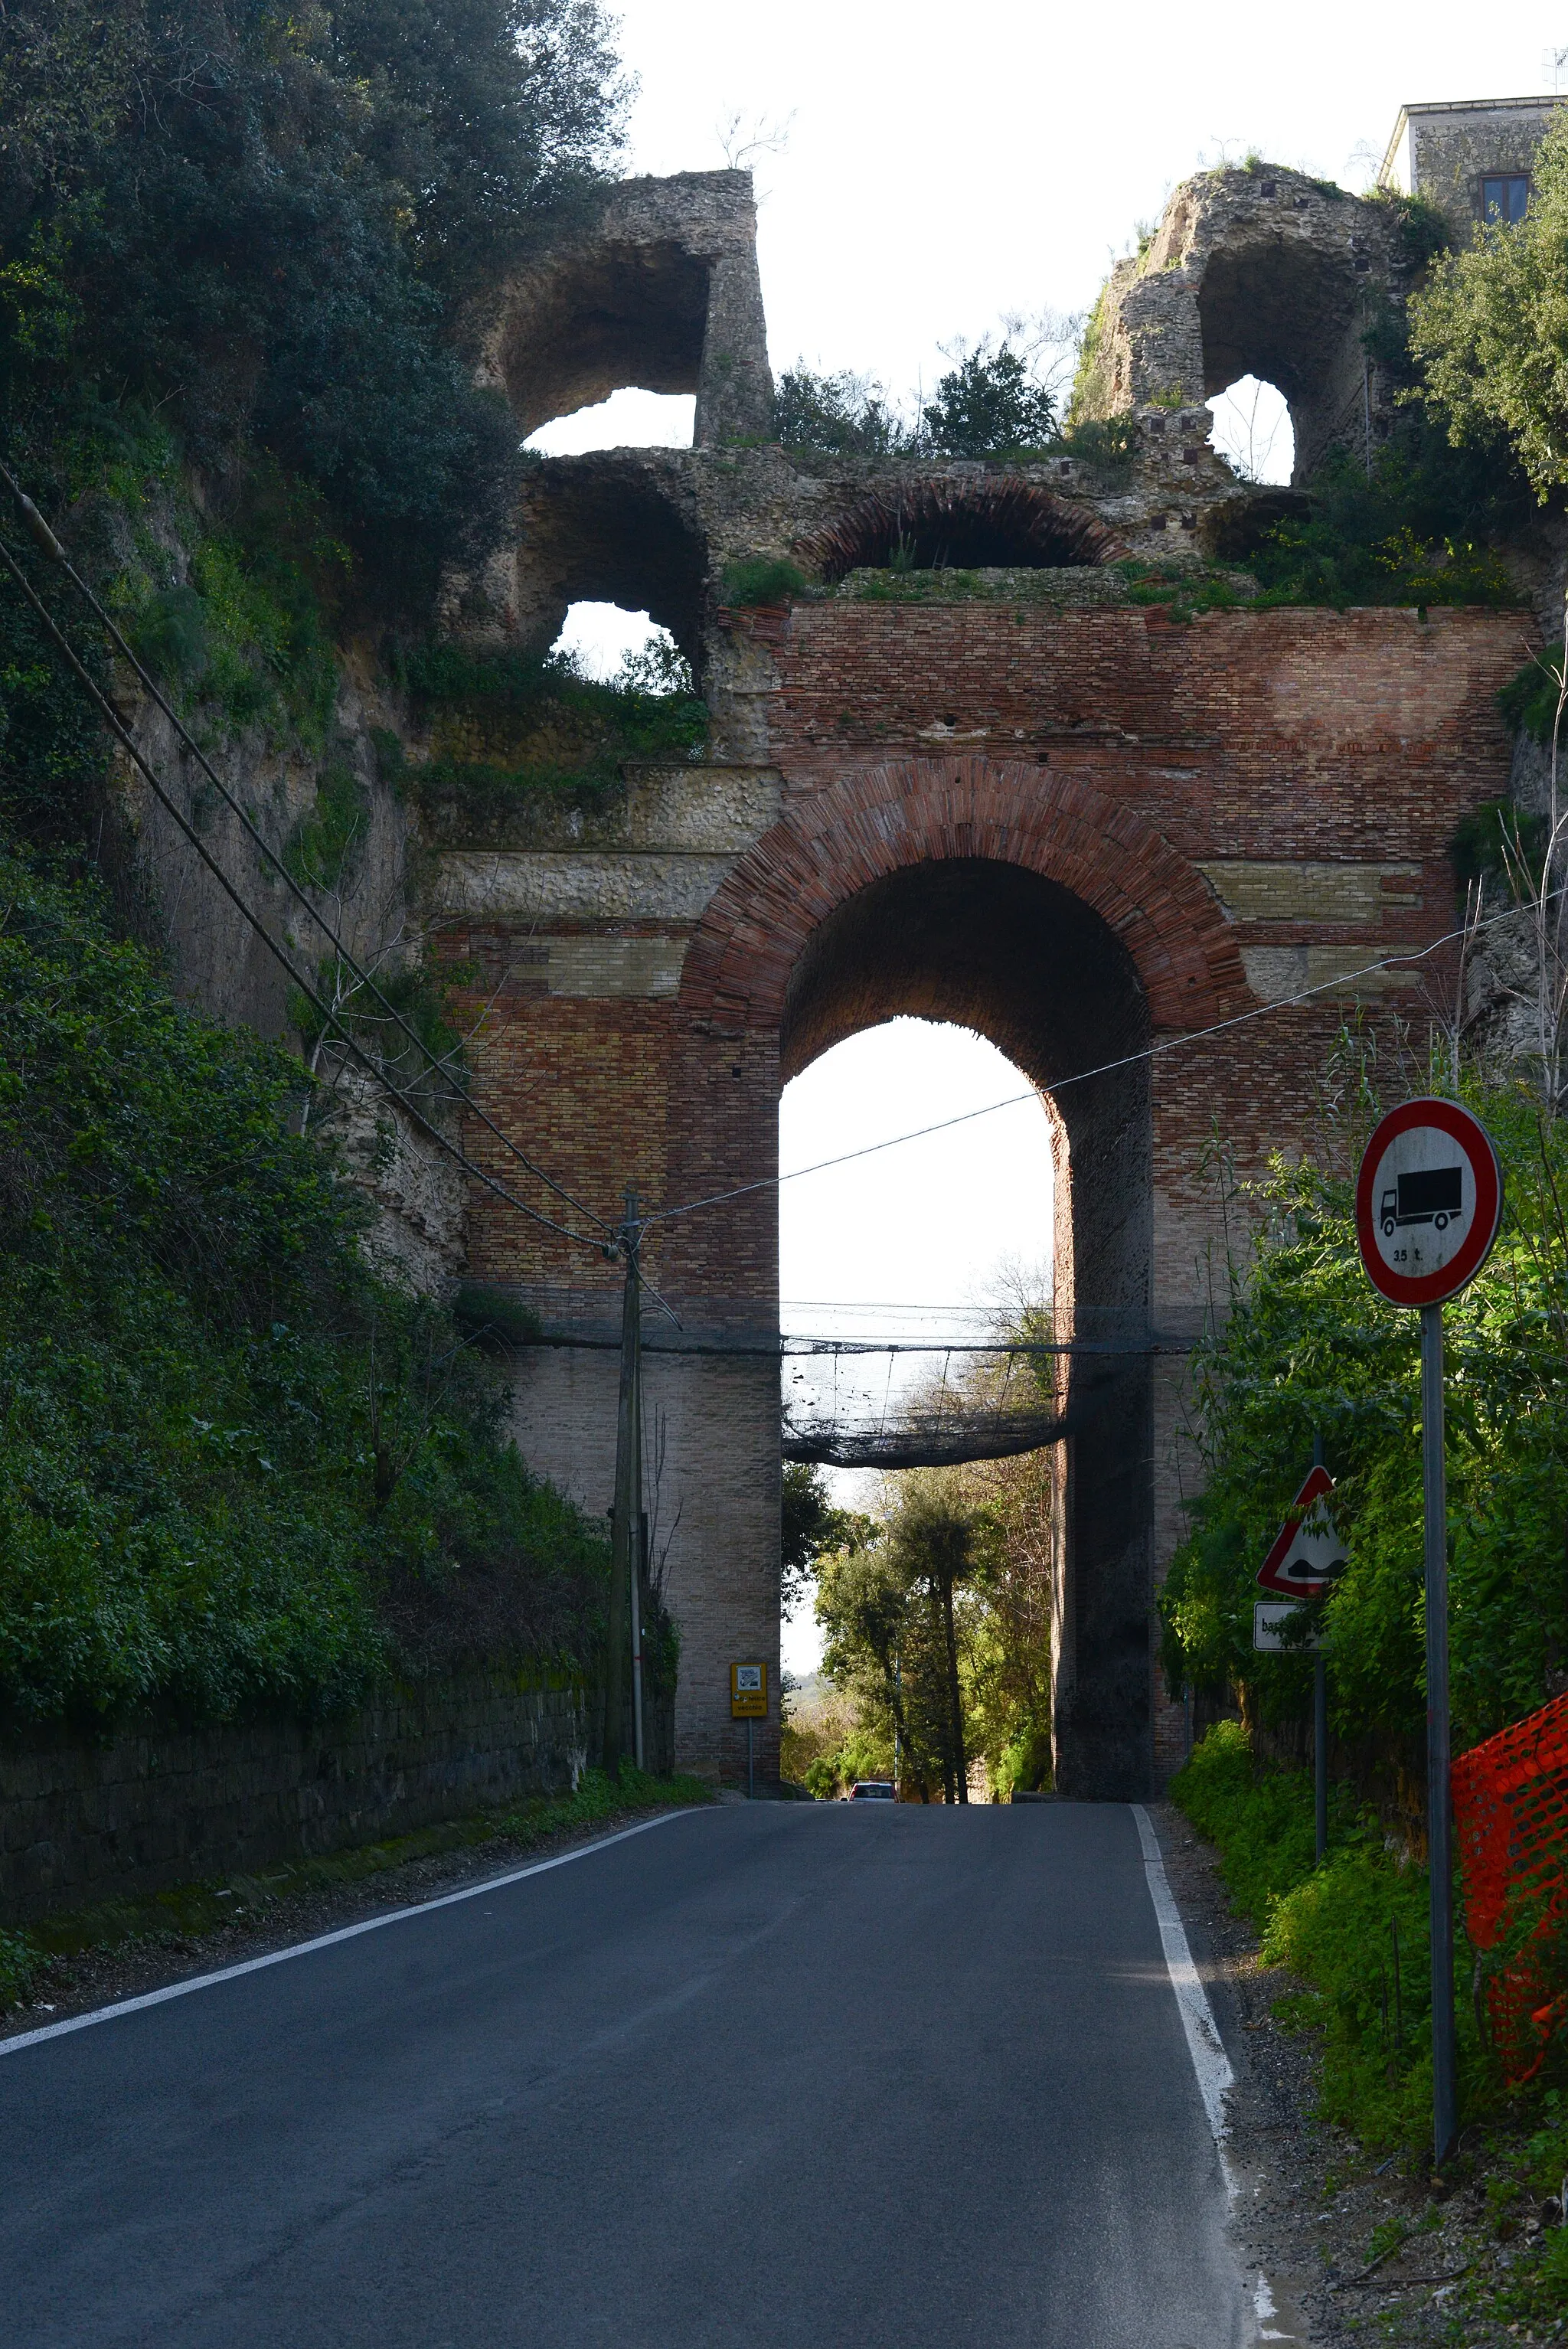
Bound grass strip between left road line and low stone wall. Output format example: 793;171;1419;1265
0;1766;714;2013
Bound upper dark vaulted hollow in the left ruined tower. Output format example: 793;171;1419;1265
495;244;709;442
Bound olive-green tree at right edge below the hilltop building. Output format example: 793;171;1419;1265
1411;117;1568;505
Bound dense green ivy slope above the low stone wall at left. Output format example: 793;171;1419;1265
0;855;608;1722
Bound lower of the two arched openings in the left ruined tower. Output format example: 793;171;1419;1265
519;453;707;671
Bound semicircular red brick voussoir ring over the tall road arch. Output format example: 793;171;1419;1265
681;756;1251;1031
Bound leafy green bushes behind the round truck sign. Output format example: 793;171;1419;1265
1160;1061;1568;1771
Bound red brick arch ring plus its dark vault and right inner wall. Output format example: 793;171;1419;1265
683;756;1244;1797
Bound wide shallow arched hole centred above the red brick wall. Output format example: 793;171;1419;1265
795;479;1125;580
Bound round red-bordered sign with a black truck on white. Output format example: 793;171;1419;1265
1357;1102;1502;1306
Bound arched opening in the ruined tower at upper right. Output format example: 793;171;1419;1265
1197;237;1366;482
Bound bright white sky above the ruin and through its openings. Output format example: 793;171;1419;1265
535;0;1568;1672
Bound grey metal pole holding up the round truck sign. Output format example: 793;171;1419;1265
1420;1304;1458;2161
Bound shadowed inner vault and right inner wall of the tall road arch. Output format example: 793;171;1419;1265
779;858;1152;1797
